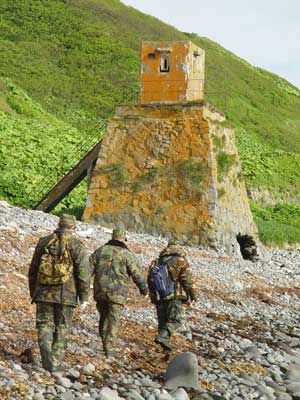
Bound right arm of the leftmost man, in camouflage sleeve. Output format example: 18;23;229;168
70;239;93;302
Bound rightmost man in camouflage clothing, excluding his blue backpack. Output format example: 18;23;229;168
148;240;197;351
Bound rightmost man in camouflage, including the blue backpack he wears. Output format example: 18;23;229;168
148;240;197;351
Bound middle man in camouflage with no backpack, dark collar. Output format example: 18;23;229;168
90;228;148;358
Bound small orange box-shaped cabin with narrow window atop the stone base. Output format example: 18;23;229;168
140;41;205;103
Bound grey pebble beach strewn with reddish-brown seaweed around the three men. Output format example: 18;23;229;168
0;202;300;400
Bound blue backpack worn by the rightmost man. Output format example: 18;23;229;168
148;256;176;300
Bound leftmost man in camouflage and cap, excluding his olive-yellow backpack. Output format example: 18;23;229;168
28;214;91;372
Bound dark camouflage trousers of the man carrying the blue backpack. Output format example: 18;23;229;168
156;299;182;335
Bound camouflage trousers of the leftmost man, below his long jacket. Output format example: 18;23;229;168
36;303;74;371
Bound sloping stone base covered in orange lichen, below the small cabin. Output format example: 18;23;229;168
84;102;256;253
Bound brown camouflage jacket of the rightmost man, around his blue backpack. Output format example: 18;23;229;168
148;246;197;303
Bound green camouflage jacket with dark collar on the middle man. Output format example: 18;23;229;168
90;240;148;304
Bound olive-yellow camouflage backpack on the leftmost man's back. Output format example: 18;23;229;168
37;233;74;285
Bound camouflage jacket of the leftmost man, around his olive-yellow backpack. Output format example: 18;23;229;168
28;230;91;306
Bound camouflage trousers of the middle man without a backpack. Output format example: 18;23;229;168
97;296;124;353
